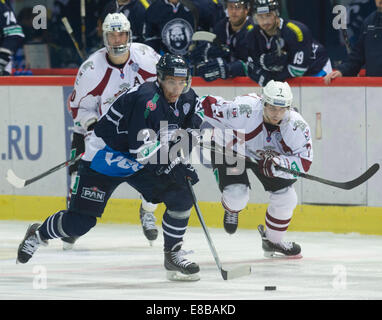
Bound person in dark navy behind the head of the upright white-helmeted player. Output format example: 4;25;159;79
97;0;151;43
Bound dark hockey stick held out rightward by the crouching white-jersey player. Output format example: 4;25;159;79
201;143;379;190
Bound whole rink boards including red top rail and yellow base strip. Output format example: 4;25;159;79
0;77;382;234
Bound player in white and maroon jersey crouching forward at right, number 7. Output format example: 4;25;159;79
202;80;313;257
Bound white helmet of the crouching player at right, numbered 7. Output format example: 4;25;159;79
262;80;293;108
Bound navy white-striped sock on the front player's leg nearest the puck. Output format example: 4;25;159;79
162;210;189;251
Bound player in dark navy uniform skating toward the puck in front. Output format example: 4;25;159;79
17;54;202;281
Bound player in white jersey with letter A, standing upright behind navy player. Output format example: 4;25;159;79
62;13;160;249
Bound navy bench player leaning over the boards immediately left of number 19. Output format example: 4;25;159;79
191;0;254;81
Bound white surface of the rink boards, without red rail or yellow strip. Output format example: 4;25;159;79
0;86;382;206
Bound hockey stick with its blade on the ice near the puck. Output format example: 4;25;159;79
187;180;251;280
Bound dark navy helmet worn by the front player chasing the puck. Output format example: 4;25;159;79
156;53;191;93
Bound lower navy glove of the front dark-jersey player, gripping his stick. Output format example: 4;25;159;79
157;157;199;185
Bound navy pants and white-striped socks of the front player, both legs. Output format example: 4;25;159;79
39;160;193;249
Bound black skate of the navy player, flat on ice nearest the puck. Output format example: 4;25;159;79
164;242;200;281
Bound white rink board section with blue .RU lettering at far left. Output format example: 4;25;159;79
0;86;68;196
